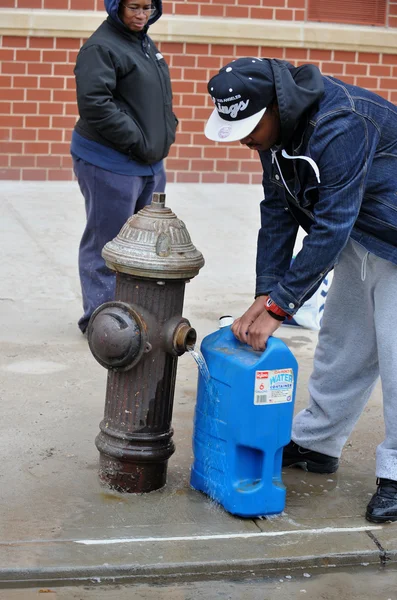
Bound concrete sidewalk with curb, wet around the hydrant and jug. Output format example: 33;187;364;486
0;183;397;587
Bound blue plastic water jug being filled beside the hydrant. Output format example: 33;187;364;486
190;326;298;517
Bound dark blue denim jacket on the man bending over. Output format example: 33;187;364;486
256;77;397;315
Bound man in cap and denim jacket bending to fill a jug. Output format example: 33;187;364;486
205;58;397;522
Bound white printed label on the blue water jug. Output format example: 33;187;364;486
254;369;294;404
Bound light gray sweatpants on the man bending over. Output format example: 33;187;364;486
292;240;397;480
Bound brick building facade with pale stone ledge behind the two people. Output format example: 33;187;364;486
0;0;397;183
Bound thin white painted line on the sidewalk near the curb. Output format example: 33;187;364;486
75;526;383;546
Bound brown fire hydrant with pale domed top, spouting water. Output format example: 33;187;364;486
88;194;204;493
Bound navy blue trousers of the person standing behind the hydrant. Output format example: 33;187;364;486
73;159;166;333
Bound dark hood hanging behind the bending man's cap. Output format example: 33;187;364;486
268;59;324;148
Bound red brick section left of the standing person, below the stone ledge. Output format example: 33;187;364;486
0;36;81;180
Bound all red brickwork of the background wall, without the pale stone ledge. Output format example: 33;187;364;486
0;0;397;183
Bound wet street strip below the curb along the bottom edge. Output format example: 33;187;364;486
0;567;397;600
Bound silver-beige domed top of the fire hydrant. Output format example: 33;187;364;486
102;193;204;279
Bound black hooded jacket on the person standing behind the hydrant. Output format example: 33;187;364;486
74;0;177;165
